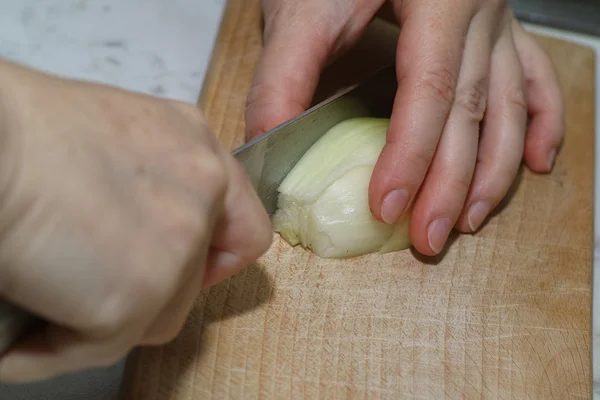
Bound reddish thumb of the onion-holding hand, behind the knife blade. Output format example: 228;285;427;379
245;17;333;139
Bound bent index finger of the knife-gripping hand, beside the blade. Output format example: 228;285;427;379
204;154;273;286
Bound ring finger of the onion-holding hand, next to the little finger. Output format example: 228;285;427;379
457;23;527;232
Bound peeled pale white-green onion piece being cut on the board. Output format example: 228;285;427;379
272;118;411;258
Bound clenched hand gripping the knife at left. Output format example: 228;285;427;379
0;63;272;382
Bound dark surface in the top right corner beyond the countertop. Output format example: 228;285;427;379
509;0;600;36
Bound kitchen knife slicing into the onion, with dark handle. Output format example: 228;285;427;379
0;65;397;354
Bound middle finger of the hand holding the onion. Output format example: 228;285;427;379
410;12;493;255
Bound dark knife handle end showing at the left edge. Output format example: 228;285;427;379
0;298;41;354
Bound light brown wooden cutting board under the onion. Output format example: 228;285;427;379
123;0;595;400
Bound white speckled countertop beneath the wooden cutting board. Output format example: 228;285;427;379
0;0;600;400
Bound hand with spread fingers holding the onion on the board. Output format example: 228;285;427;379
246;0;564;255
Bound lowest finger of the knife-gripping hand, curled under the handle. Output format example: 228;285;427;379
0;325;125;383
